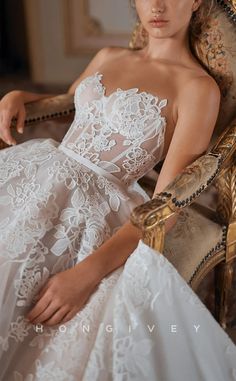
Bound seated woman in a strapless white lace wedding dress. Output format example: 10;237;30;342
0;0;236;381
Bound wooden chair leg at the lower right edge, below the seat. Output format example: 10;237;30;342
215;260;234;329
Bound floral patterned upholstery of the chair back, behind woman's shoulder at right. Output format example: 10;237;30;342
195;5;236;144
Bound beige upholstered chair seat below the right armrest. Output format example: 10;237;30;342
163;203;224;282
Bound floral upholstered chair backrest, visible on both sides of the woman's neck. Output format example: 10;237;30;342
129;0;236;146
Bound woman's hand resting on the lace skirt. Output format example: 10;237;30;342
26;261;100;326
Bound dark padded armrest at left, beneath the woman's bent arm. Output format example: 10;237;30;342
12;94;75;127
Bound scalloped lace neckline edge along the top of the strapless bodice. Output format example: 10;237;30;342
78;71;168;105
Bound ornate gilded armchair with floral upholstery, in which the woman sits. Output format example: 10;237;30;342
0;0;236;328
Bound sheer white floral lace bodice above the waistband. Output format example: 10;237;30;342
61;72;167;184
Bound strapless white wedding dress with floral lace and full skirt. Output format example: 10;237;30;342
0;72;236;381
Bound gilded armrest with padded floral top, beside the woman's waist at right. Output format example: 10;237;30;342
130;152;222;231
